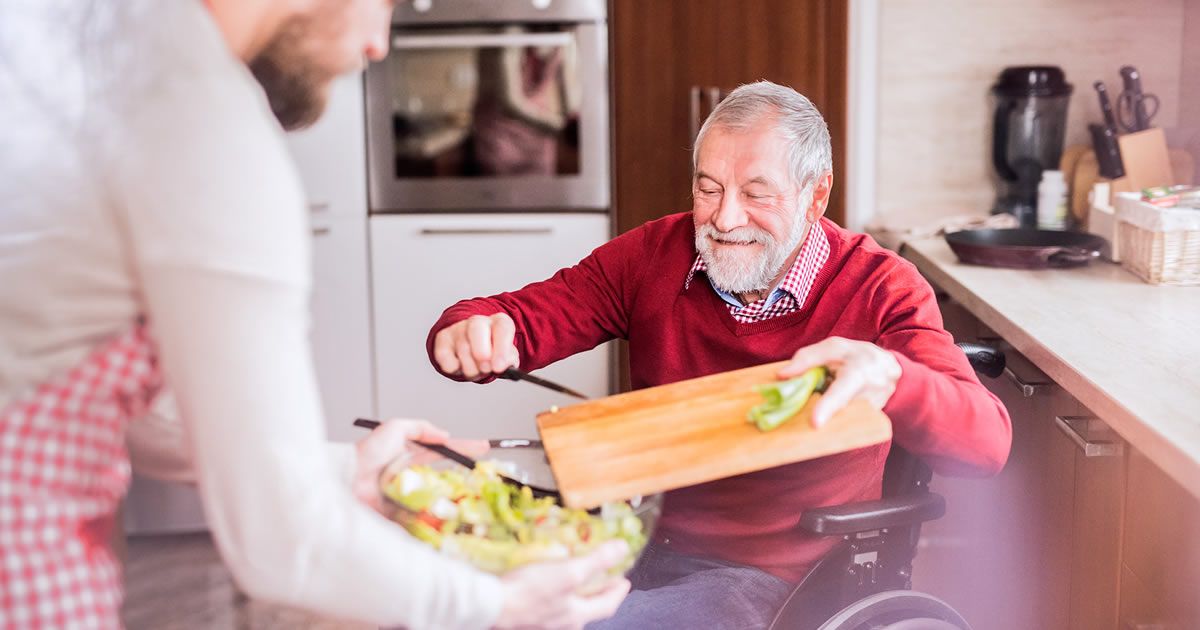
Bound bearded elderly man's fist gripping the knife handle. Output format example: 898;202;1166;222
433;313;520;380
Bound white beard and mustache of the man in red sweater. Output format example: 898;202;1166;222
696;214;808;293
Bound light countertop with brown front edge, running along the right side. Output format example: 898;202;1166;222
900;238;1200;498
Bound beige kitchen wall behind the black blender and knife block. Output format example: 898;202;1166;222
874;0;1200;227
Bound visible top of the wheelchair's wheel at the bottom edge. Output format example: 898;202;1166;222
817;590;971;630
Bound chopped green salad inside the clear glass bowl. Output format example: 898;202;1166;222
383;461;647;574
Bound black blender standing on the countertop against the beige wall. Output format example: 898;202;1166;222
991;66;1072;228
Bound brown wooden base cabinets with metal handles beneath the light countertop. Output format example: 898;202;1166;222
913;295;1200;630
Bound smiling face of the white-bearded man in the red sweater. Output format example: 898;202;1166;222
692;122;812;293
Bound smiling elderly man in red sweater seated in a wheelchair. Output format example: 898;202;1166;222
428;82;1012;628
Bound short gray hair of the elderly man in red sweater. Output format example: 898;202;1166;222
691;80;833;188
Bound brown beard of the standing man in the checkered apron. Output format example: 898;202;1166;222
250;18;334;131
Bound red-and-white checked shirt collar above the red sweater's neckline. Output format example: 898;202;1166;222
684;223;829;324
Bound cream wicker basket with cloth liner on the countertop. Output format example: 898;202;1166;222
1117;193;1200;286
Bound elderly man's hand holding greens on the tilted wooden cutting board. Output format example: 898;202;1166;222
779;337;900;427
